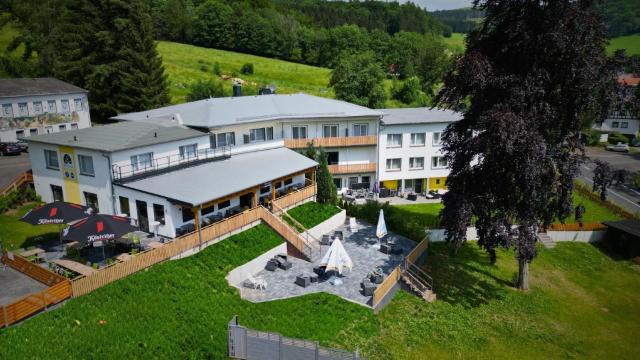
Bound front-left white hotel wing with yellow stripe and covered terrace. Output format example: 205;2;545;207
28;122;316;238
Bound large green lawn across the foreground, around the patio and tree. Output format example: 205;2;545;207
0;225;640;360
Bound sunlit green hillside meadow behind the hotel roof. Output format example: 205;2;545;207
158;41;333;103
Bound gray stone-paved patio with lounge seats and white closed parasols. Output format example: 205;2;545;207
241;219;416;306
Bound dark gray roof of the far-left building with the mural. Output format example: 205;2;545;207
0;78;87;97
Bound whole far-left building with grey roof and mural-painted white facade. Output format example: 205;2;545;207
0;78;91;142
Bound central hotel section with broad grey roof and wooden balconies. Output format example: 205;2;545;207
113;94;382;190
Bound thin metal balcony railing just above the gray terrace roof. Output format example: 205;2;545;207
111;147;231;182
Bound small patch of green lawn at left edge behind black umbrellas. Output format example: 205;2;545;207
0;203;60;250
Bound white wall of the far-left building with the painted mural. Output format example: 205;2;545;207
0;93;91;142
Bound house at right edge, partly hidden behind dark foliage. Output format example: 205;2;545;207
593;74;640;138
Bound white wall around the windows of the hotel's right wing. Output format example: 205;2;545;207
378;123;449;181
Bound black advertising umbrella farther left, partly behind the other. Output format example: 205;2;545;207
20;201;89;225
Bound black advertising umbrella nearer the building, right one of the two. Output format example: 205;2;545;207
62;214;138;246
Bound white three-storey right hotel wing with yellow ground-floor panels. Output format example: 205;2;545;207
378;108;461;194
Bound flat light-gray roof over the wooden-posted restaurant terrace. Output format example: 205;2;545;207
118;147;317;206
